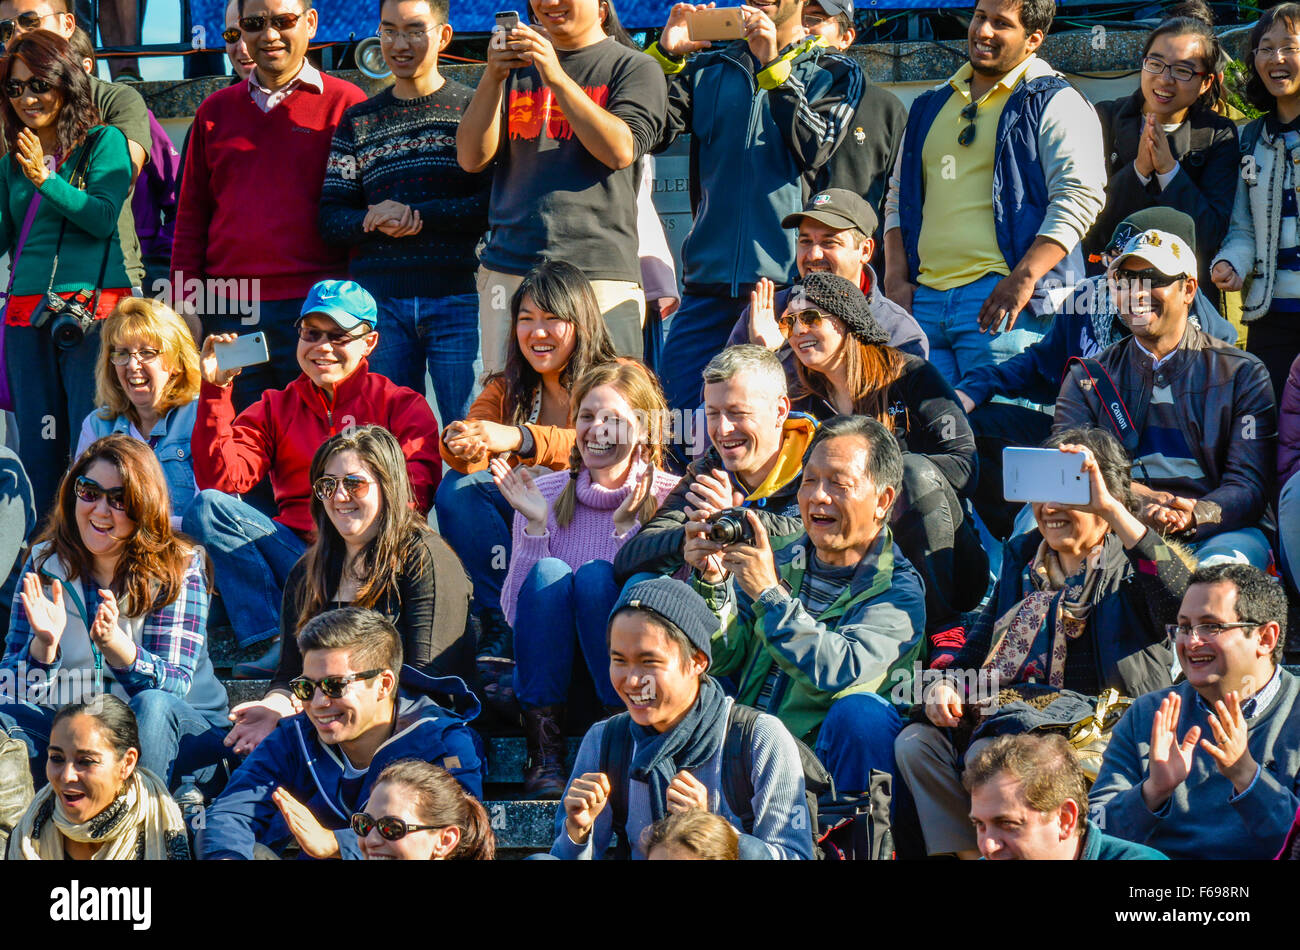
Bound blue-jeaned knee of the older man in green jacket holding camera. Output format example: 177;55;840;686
813;693;902;793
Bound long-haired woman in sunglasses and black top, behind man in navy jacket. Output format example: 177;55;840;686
226;425;475;755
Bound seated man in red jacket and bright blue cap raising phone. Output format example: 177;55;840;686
182;281;442;676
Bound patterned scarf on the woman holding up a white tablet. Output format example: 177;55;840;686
983;541;1105;689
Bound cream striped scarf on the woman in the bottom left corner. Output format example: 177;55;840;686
9;768;190;860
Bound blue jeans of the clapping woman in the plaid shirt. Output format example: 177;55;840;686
0;689;230;798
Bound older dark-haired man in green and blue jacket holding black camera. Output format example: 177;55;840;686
685;416;926;793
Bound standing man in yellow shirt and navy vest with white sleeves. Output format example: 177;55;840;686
885;0;1106;400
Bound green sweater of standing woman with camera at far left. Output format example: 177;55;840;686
0;126;131;295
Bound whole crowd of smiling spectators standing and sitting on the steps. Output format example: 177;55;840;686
0;0;1300;860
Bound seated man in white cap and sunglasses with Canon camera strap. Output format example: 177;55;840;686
1052;229;1278;569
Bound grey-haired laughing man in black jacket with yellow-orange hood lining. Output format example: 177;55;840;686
614;343;816;584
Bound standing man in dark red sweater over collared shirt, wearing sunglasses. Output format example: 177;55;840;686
172;0;365;409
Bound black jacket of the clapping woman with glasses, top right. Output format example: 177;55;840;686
1083;90;1240;287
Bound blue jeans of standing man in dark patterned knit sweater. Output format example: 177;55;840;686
371;294;482;426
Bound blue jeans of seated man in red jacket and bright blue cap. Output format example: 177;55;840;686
181;489;307;647
